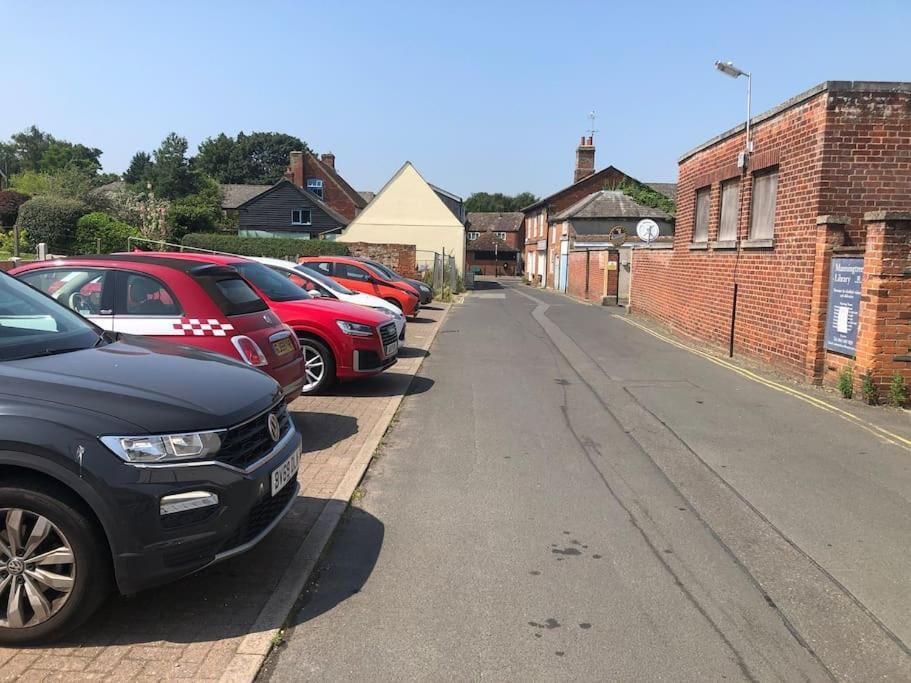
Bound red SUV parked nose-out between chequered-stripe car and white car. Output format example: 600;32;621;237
134;253;398;394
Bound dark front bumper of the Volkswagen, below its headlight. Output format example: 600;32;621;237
100;426;301;594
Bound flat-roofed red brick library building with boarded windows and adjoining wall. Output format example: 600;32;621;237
630;81;911;398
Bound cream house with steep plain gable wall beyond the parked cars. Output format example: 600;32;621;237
338;161;474;273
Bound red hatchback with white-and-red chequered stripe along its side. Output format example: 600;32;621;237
10;253;304;403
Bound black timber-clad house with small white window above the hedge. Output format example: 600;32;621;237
237;180;349;239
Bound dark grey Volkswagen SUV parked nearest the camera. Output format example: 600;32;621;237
0;273;301;645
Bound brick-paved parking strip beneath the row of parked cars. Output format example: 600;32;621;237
0;304;448;682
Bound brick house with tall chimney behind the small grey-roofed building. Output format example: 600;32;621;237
522;136;661;290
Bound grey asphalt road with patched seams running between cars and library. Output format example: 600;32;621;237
261;284;911;681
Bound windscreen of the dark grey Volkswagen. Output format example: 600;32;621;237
0;273;102;361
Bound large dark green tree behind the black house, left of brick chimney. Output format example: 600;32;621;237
193;132;309;185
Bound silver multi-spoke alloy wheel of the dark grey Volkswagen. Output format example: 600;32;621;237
0;508;76;628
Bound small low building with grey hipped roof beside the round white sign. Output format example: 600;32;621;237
548;190;674;303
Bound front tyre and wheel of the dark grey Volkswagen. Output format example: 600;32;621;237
0;482;112;645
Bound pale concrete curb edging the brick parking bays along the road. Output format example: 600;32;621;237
220;304;452;683
